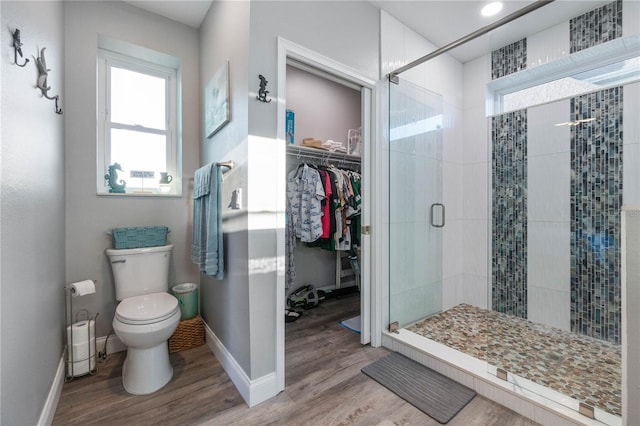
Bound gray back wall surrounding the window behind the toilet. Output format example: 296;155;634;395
60;2;200;336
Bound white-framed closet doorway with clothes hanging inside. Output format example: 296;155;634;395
276;38;376;390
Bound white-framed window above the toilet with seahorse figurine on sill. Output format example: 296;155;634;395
97;49;182;195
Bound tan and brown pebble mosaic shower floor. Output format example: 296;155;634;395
407;304;622;416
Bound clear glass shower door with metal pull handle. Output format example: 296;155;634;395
388;79;446;328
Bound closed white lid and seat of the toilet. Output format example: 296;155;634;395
116;293;180;324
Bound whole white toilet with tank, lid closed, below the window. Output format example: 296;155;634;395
107;244;180;395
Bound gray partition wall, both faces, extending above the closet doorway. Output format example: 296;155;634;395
200;1;379;379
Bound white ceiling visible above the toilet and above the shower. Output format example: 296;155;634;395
127;0;611;62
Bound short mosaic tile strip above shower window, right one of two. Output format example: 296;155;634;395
569;0;622;53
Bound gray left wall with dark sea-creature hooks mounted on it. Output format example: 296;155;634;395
0;1;65;425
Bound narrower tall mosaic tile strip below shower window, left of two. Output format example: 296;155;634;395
491;110;527;318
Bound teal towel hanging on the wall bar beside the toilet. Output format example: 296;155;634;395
191;164;224;280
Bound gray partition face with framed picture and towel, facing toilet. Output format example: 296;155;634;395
200;2;254;377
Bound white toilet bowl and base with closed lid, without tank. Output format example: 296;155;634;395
113;293;180;395
